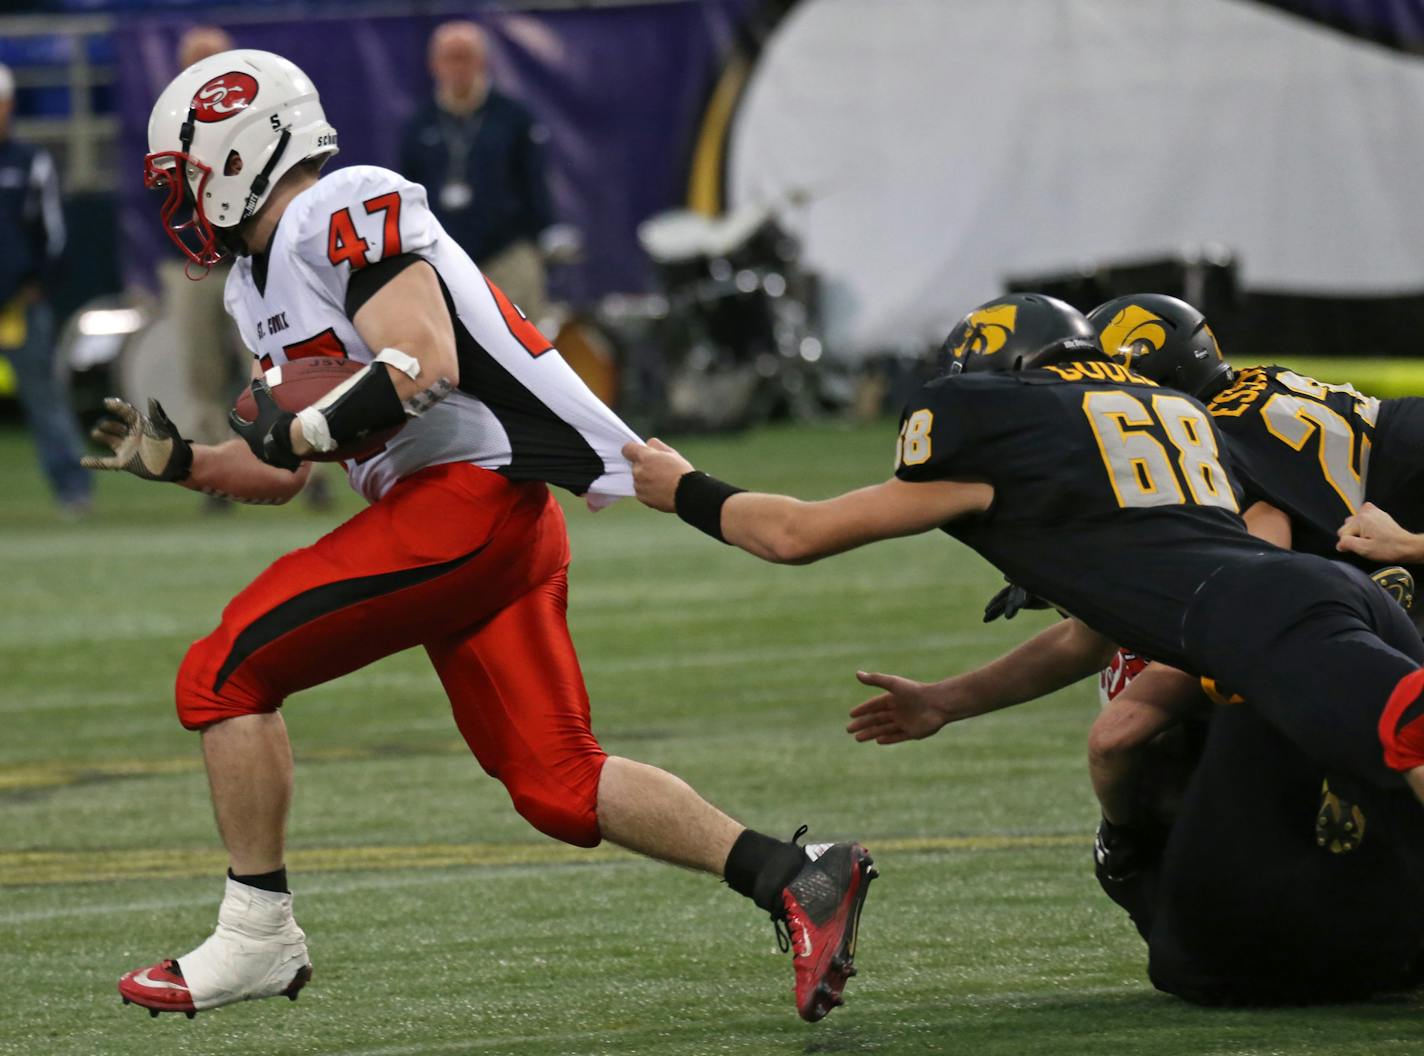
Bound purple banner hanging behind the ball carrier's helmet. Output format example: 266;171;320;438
117;0;756;303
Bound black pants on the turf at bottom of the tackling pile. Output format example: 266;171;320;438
1099;706;1424;1005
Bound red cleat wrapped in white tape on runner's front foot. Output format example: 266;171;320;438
118;877;312;1019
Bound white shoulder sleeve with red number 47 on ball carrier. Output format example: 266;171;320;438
295;165;440;312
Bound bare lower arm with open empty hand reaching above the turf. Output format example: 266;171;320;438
846;619;1115;744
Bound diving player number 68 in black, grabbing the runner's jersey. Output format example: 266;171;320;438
625;295;1424;993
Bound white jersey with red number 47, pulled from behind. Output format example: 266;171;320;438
225;165;638;507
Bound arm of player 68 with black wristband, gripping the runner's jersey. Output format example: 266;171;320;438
622;440;994;565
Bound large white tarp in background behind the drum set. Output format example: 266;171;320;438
729;0;1424;352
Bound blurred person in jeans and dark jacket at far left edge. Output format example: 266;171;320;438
0;65;94;515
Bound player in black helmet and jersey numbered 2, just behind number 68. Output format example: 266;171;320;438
1088;293;1424;854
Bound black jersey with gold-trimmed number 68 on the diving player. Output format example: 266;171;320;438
896;361;1276;673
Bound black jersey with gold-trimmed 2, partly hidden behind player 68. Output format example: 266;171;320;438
1206;366;1380;558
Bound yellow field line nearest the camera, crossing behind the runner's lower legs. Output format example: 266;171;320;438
0;834;1070;887
